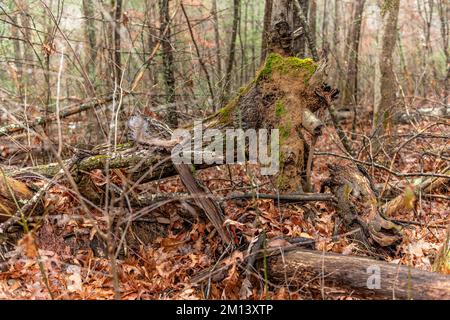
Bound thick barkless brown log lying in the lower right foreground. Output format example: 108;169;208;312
269;249;450;300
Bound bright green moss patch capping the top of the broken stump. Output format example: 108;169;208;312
255;53;317;83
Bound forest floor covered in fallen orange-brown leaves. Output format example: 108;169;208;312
0;117;450;299
